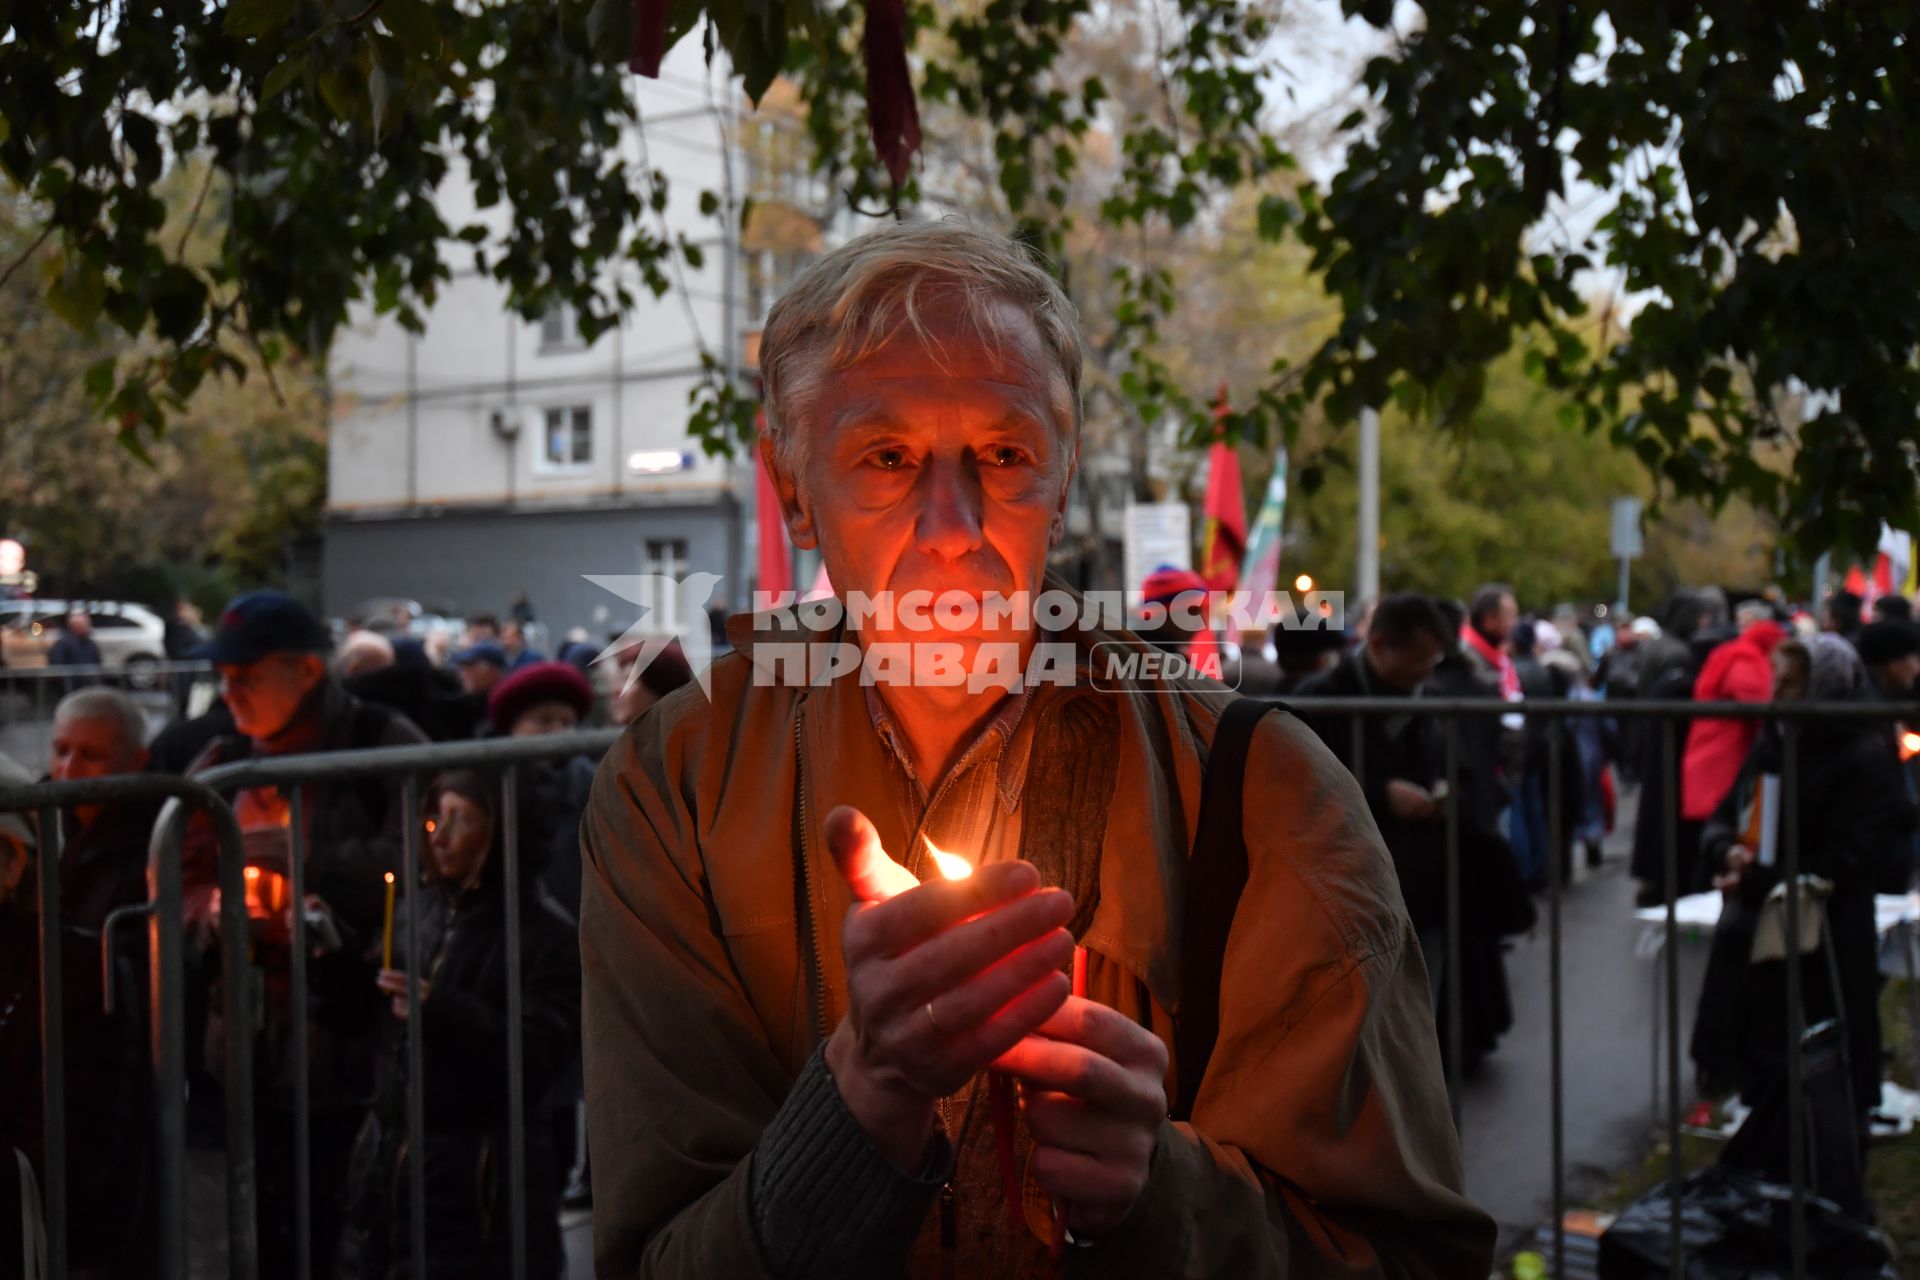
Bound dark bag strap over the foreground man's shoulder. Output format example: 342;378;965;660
1173;699;1292;1121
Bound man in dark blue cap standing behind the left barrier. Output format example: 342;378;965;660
180;591;426;1274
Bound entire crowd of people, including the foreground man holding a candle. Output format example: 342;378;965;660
15;223;1920;1280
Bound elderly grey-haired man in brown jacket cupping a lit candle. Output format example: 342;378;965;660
580;223;1494;1278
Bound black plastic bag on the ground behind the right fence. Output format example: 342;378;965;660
1599;1165;1897;1280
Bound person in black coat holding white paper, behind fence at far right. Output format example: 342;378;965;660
1692;633;1914;1132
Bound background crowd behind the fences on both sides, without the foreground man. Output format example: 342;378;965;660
0;574;1920;1276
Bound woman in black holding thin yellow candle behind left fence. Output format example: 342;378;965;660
340;770;580;1278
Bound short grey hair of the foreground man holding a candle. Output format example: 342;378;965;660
760;221;1085;468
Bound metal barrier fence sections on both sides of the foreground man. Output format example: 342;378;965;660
0;699;1920;1280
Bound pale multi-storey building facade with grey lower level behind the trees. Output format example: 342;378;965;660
321;40;753;637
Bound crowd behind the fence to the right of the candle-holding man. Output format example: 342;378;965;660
1205;581;1920;1205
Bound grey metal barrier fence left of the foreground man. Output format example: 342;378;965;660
0;729;618;1280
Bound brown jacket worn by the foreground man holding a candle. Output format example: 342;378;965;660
580;610;1494;1280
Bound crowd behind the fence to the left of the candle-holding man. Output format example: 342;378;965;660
0;591;691;1276
